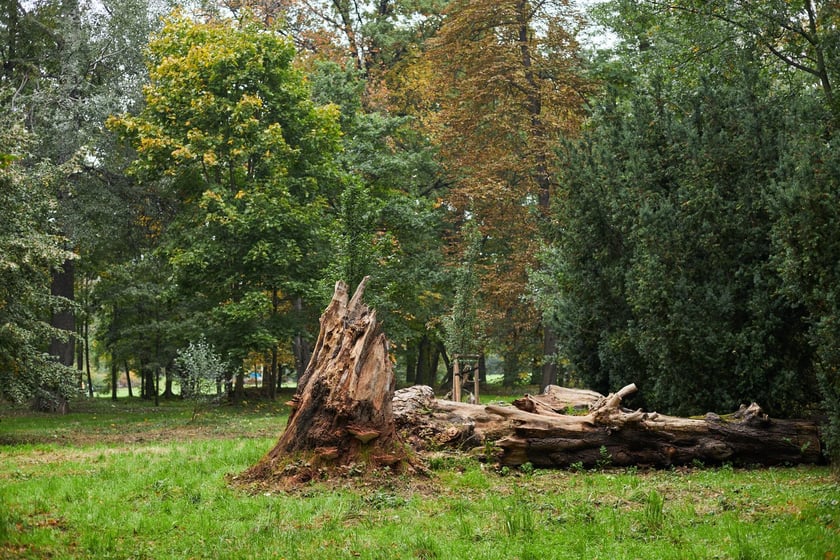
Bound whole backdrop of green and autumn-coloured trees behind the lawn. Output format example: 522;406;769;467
0;0;840;457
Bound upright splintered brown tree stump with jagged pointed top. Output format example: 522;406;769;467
238;278;412;483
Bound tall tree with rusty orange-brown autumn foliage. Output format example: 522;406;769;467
418;0;586;384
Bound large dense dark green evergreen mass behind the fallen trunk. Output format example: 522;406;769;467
535;3;825;420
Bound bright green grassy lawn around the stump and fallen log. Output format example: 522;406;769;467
0;399;840;560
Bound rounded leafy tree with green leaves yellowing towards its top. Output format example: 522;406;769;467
109;12;340;400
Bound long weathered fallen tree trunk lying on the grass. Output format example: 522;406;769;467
398;385;821;468
